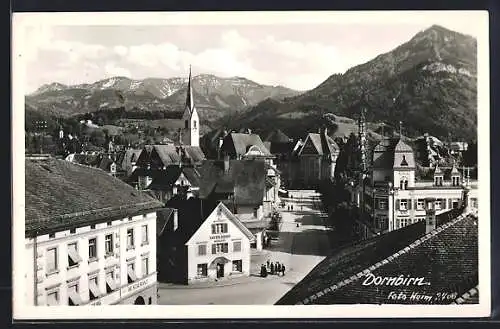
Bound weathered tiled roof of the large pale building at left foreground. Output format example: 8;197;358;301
25;159;162;234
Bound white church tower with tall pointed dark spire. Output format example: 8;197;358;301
182;67;200;146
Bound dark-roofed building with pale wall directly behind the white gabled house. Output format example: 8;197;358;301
199;156;274;250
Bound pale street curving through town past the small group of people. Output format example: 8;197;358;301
159;191;331;305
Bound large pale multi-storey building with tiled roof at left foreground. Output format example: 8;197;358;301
24;157;163;306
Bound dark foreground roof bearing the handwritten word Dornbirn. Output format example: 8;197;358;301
277;209;470;305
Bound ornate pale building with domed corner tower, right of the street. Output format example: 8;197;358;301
351;137;478;233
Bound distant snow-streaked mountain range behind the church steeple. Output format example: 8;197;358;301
25;74;299;119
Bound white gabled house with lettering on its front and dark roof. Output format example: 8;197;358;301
158;198;254;284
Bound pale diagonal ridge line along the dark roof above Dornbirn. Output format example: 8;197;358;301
297;213;469;305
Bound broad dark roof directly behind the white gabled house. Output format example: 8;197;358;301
200;160;266;205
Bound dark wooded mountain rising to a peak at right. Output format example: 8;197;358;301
223;25;477;140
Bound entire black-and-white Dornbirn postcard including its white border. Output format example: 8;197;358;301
12;11;491;320
